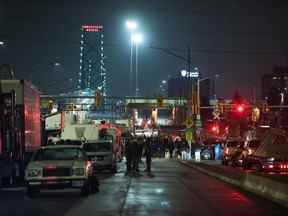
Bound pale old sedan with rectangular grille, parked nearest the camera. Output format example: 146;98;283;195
25;145;99;196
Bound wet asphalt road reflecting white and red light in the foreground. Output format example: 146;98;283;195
0;159;288;216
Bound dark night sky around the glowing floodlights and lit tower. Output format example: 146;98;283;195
0;0;288;97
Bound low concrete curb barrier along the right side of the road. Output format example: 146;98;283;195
179;160;288;208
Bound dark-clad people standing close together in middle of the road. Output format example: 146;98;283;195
125;136;152;174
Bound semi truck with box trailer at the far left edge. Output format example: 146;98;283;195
0;80;41;185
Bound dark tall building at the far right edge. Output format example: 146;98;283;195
262;66;288;105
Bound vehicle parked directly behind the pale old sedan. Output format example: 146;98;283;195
83;140;117;173
